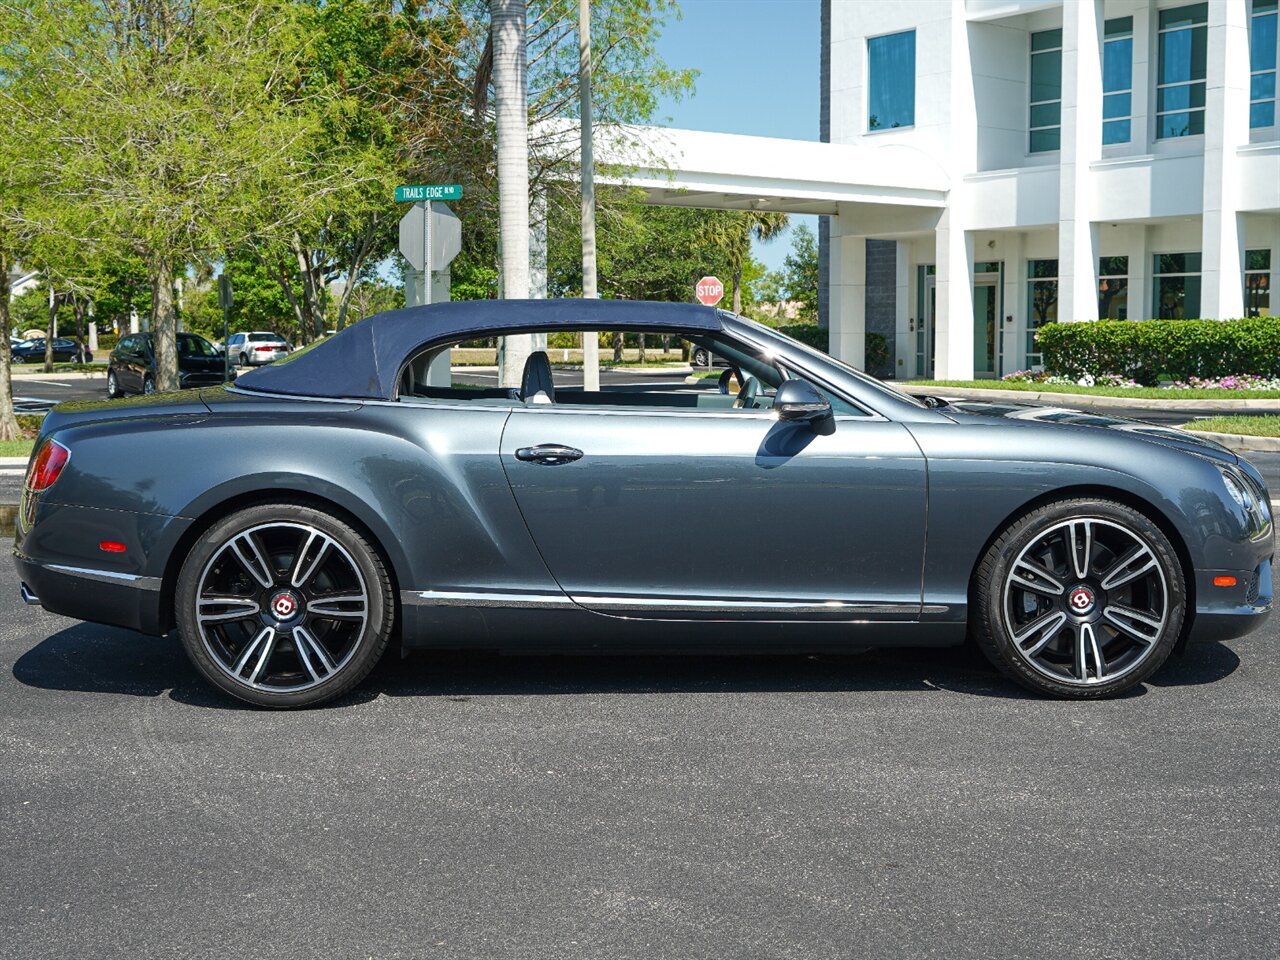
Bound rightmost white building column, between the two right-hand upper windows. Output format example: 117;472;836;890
1199;3;1249;320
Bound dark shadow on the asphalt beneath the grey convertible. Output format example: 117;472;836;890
13;623;1240;709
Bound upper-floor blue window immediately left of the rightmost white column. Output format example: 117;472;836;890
1156;4;1208;140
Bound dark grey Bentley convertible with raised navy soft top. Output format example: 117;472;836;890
14;300;1275;707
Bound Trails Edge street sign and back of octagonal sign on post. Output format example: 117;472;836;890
396;183;462;387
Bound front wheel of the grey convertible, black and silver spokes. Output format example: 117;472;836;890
974;499;1187;698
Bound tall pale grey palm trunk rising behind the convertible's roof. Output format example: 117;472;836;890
489;0;532;387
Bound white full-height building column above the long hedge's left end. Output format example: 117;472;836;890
1057;0;1102;320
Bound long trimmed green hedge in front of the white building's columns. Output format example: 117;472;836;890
1036;316;1280;385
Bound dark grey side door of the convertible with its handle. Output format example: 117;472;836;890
502;396;925;620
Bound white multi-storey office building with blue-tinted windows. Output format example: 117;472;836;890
823;0;1280;379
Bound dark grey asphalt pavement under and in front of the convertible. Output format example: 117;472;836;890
0;564;1280;960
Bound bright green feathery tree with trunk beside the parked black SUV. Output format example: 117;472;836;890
13;0;366;389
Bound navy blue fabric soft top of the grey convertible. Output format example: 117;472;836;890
236;300;721;399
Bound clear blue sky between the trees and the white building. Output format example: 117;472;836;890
658;0;819;268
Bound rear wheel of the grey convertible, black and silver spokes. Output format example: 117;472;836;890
177;504;394;707
